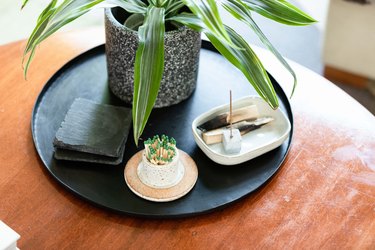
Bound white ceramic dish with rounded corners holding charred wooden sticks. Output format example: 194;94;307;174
192;96;291;165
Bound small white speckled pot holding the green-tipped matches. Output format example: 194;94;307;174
137;150;185;188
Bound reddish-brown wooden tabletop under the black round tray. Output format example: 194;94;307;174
0;29;375;249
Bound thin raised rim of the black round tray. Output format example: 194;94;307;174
30;40;294;219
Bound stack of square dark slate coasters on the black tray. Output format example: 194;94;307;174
53;98;132;165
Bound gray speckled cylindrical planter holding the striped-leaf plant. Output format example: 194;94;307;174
105;8;201;107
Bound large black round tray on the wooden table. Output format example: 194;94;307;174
31;41;293;218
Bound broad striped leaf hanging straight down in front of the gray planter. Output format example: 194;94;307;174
133;6;165;145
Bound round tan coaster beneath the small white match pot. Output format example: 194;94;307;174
124;150;198;202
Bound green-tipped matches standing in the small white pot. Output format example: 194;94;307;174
144;135;176;165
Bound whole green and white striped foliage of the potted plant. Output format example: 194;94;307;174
22;0;315;143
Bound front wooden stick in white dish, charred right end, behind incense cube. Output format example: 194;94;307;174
202;117;274;145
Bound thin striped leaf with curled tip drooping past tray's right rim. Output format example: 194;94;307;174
222;0;297;96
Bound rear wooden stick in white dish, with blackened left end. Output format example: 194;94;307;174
197;105;259;132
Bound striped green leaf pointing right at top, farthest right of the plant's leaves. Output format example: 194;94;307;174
241;0;316;25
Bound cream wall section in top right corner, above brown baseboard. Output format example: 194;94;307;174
323;0;375;79
